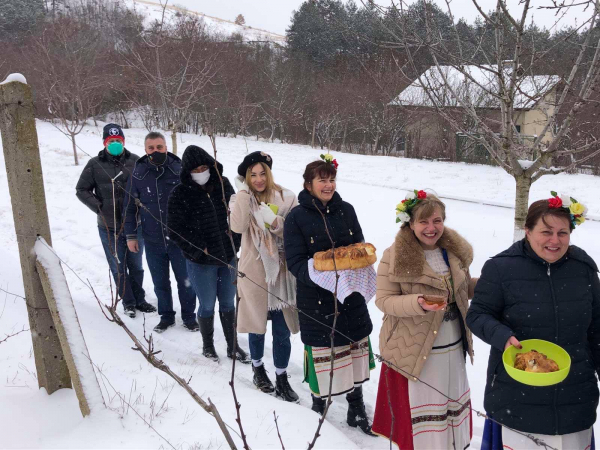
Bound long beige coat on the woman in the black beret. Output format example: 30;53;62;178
229;185;300;334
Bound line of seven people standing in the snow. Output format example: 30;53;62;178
77;124;600;450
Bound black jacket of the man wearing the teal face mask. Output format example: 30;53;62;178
75;149;139;230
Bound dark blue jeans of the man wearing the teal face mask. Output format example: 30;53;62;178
98;227;146;308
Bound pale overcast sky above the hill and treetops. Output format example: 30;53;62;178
182;0;589;34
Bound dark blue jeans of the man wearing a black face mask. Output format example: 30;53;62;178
145;239;196;322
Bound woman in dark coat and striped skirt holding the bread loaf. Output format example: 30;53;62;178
284;161;374;434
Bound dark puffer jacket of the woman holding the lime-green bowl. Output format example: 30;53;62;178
467;240;600;435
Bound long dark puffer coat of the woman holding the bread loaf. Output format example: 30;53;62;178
283;189;373;347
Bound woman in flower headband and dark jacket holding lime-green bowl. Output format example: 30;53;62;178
467;196;600;450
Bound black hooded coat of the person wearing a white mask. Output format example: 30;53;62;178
167;145;241;266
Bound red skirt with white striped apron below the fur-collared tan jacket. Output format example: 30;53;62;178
373;318;473;450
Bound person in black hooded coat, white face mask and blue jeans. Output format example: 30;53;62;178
167;145;250;363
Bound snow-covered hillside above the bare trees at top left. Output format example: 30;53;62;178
126;0;286;45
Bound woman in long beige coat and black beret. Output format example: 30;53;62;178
229;152;299;402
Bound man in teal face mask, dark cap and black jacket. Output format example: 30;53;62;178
75;123;156;317
